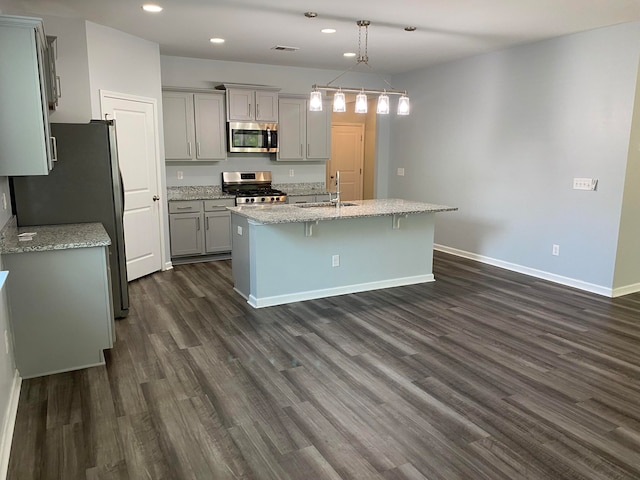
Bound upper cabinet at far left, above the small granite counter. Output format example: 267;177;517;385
0;15;55;176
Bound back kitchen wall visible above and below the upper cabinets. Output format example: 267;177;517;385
160;56;390;186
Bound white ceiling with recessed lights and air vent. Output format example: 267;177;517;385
0;0;640;74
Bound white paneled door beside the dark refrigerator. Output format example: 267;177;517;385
100;92;162;281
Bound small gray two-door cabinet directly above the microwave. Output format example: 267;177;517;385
227;88;278;123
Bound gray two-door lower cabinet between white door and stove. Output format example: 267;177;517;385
169;198;235;257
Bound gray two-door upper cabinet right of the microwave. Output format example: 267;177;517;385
277;96;331;161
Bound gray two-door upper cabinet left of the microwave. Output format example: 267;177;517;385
162;90;227;161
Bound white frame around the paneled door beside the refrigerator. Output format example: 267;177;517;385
99;89;173;271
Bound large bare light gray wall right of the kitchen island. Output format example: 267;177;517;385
387;23;640;293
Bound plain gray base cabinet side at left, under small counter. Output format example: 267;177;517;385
2;247;115;378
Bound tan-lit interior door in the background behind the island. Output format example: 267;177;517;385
327;123;364;200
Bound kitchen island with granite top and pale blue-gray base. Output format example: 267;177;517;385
229;199;457;308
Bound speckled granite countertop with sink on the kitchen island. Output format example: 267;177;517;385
227;199;458;225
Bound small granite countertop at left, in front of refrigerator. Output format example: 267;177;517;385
0;217;111;254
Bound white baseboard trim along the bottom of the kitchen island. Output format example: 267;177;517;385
242;273;435;308
